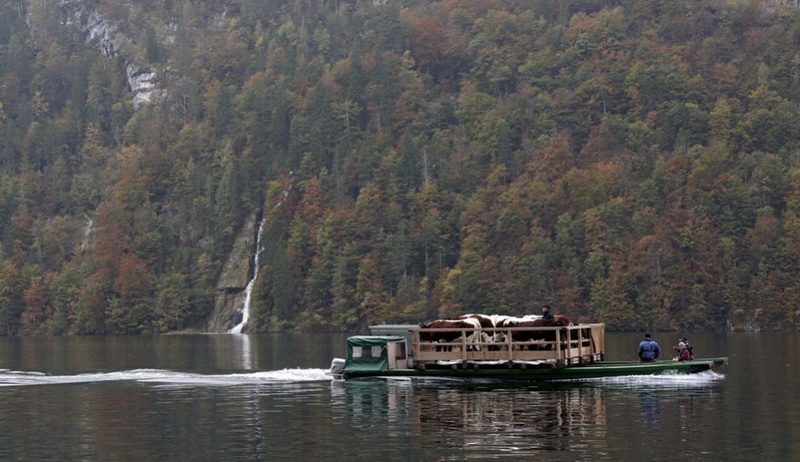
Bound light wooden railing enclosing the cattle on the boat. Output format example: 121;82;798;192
411;324;605;369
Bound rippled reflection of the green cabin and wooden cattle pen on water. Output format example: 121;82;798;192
333;379;607;456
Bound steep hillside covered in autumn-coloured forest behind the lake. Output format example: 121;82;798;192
0;0;800;335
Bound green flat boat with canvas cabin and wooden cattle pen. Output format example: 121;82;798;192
330;324;727;381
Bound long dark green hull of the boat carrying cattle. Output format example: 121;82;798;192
344;358;727;381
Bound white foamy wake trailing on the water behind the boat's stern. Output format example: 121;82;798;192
0;369;331;387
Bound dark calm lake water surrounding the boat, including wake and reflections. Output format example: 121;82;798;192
0;333;800;460
